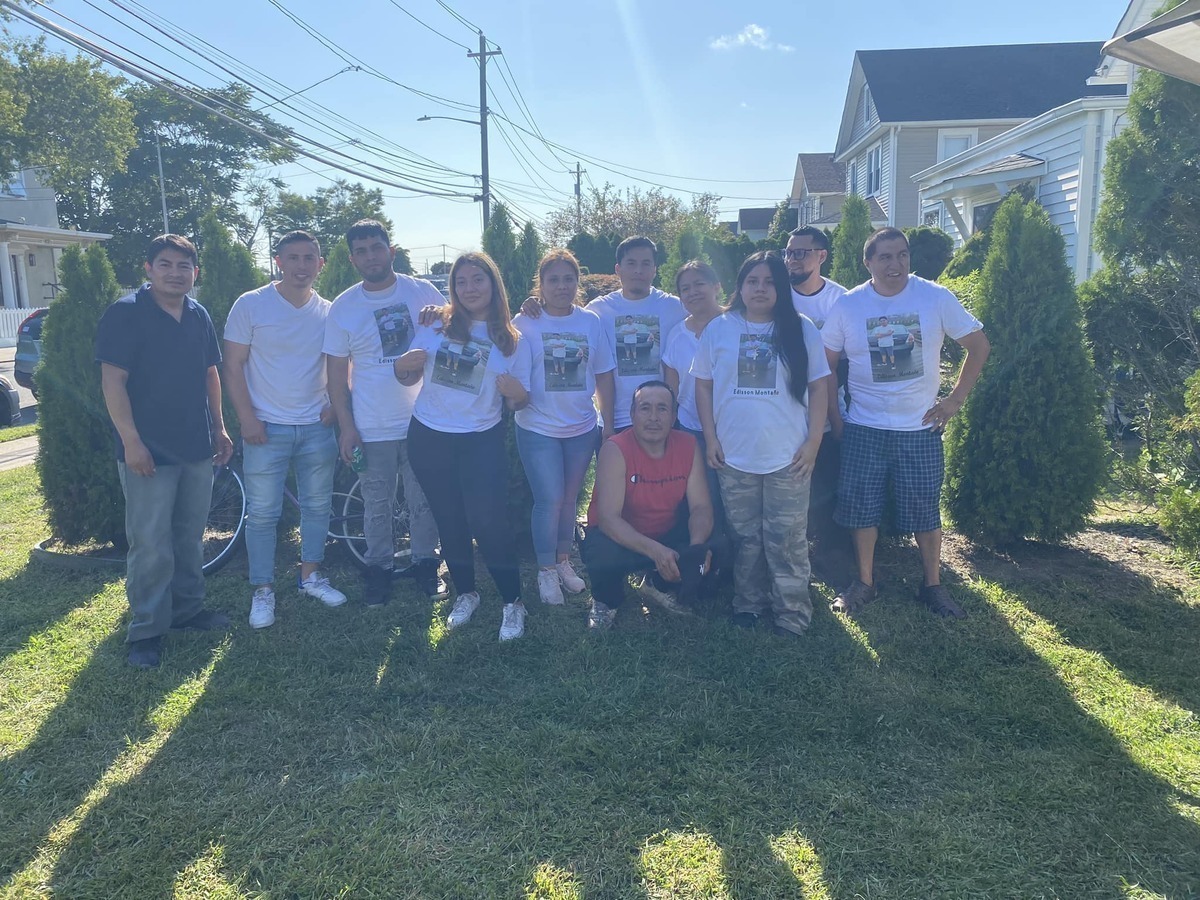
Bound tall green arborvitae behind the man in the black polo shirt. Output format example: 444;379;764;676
37;244;125;546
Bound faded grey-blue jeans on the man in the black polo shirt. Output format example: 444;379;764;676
116;460;212;642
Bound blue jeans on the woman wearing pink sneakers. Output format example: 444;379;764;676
516;425;600;566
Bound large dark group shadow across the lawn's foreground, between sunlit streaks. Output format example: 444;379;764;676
4;547;1200;900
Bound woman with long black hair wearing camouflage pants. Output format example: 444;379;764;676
691;252;829;637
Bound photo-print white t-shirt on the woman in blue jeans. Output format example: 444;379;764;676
512;307;617;438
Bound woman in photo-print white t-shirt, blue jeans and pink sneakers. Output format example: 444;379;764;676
512;250;617;605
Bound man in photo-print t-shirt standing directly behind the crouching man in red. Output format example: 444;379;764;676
521;238;688;439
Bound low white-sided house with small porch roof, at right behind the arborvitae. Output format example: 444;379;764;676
912;0;1160;281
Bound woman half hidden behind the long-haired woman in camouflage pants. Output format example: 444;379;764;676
662;259;724;532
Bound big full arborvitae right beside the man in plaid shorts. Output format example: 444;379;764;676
946;196;1105;546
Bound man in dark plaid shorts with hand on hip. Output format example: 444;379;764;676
821;228;991;618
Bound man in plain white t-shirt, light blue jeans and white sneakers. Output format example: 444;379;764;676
224;232;346;628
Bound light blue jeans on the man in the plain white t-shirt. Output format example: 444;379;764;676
241;422;337;586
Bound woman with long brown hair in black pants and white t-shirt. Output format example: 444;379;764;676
394;253;529;641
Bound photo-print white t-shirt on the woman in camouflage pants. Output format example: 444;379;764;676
691;312;829;475
